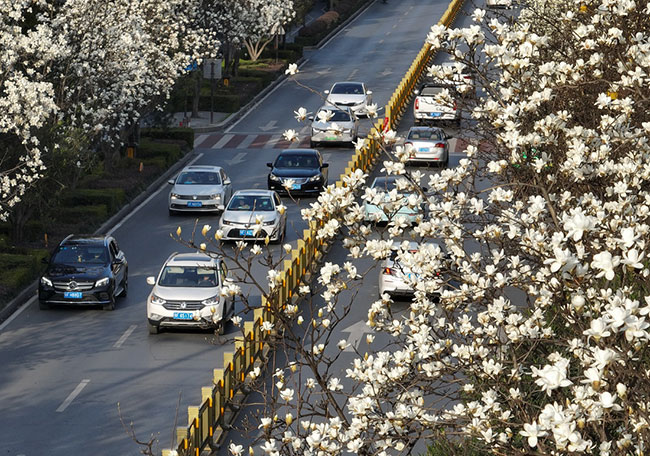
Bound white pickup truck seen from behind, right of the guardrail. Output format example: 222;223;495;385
413;82;460;125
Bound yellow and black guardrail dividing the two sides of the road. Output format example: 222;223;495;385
162;0;463;456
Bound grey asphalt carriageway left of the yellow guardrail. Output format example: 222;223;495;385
0;0;468;456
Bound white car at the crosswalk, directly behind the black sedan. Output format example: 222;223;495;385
309;105;359;147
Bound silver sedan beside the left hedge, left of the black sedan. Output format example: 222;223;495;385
169;165;232;215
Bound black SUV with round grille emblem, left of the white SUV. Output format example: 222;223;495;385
38;234;129;310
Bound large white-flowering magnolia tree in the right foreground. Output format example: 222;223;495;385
187;0;650;455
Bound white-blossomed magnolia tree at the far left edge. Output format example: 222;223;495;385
0;0;63;220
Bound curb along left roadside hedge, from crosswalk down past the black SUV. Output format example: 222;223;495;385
0;149;196;323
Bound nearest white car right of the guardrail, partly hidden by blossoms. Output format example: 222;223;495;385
379;241;447;298
